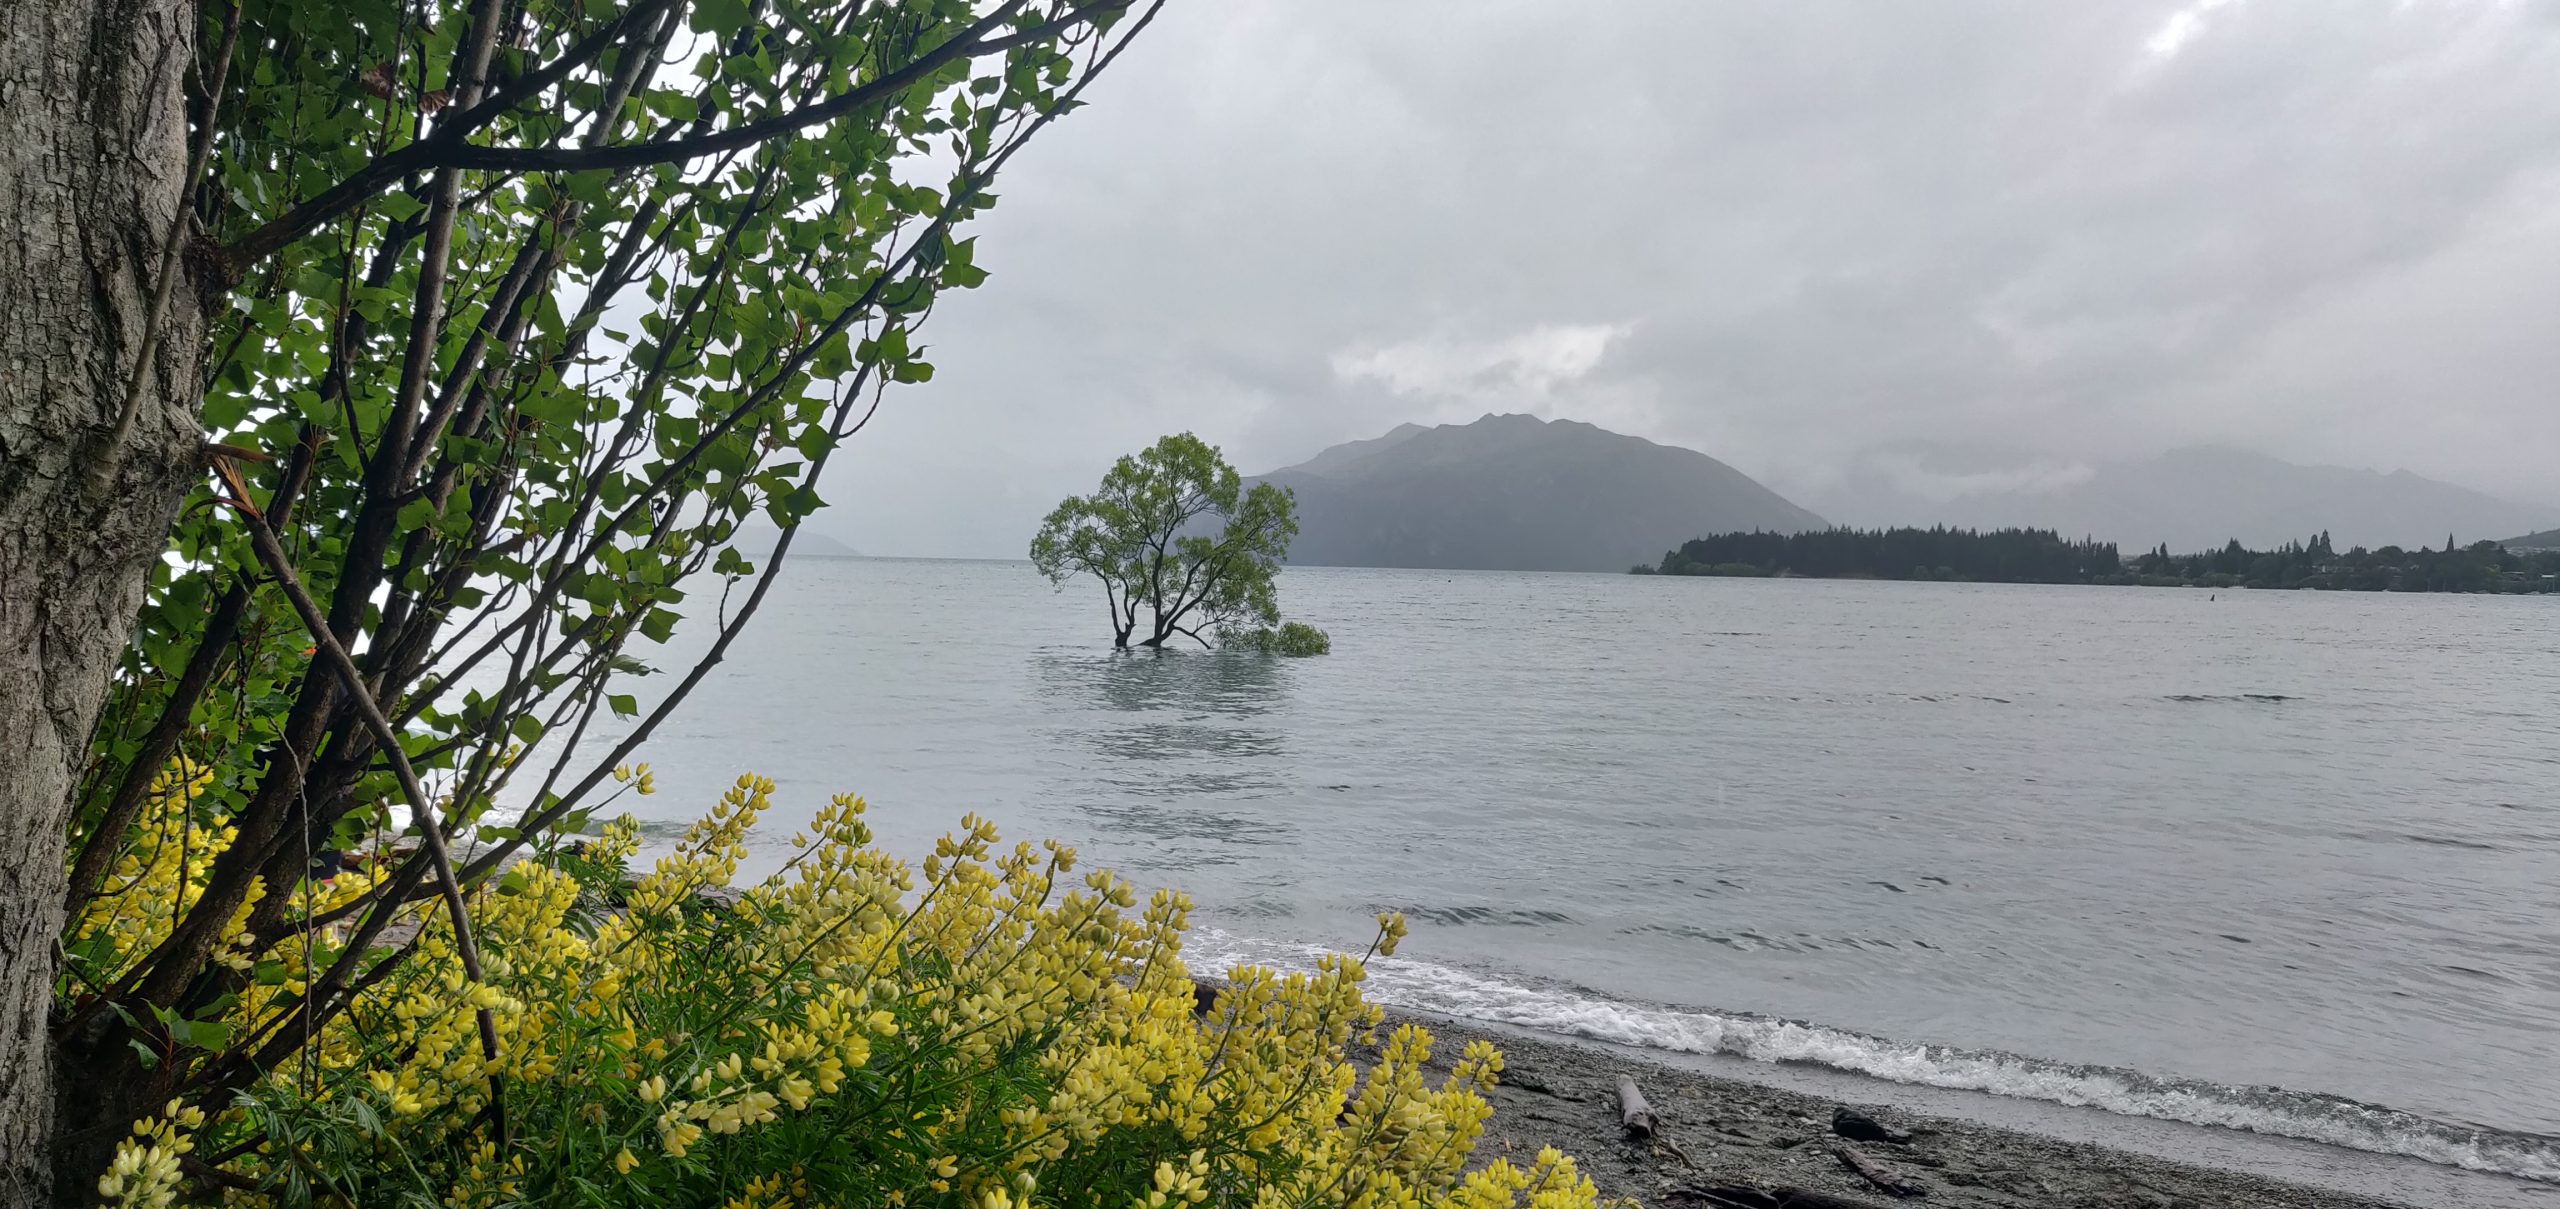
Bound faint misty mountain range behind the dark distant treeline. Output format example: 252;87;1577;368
1823;446;2555;553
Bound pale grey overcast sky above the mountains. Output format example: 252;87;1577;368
817;0;2560;556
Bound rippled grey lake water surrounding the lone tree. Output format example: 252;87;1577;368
593;561;2560;1204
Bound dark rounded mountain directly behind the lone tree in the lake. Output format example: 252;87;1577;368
1262;415;1823;571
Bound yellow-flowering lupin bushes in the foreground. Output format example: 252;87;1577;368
90;776;1595;1209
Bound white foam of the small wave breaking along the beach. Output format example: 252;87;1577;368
1185;927;2560;1183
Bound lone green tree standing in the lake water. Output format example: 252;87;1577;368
1032;433;1298;648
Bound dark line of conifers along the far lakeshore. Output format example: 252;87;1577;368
1633;525;2560;592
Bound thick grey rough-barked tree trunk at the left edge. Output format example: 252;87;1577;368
0;0;205;1209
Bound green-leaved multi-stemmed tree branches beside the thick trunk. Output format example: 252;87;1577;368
56;0;1155;1173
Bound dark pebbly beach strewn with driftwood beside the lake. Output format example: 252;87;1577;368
1388;1009;2508;1209
